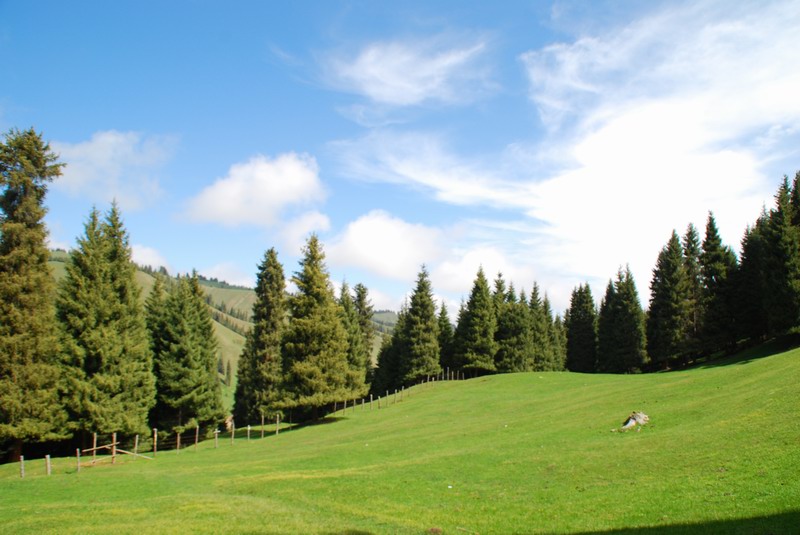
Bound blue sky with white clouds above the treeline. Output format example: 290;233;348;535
0;0;800;314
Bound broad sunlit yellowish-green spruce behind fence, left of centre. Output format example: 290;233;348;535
281;235;354;418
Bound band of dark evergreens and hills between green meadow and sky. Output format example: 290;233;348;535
0;129;800;458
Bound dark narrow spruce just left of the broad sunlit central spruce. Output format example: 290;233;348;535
233;248;286;423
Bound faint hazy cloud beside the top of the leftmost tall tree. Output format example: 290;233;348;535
52;130;176;210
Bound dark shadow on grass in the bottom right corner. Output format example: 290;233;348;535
585;511;800;535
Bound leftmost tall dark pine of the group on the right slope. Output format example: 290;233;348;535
647;231;692;368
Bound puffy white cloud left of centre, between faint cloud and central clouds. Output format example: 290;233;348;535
187;152;325;227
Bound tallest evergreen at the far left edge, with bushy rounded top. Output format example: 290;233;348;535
0;129;66;460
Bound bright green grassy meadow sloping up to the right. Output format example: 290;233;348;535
0;342;800;534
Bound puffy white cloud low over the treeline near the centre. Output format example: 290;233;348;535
327;210;444;280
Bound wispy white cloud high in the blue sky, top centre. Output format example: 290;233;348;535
326;36;490;106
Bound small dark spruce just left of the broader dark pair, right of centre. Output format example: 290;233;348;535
566;283;597;373
